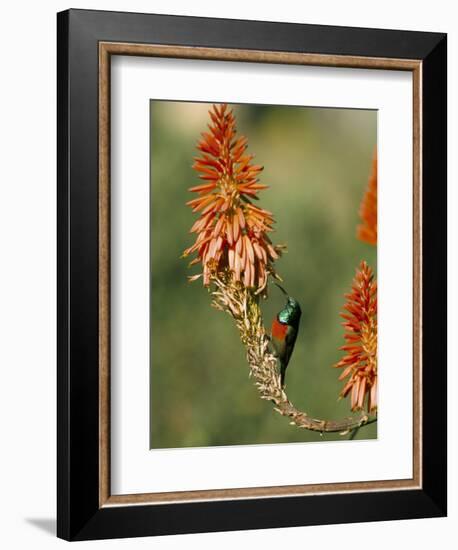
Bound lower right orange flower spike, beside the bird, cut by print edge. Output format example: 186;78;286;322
334;261;377;412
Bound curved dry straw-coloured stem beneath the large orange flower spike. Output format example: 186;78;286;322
212;271;377;435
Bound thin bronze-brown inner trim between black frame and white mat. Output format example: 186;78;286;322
99;42;422;508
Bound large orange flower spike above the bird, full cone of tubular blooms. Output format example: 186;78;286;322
183;104;281;292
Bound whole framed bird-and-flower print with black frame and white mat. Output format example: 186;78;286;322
58;10;446;540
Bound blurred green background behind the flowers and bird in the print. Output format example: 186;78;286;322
150;101;377;448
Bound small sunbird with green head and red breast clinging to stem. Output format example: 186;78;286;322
271;283;302;387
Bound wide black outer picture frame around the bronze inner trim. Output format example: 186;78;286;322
57;10;447;540
